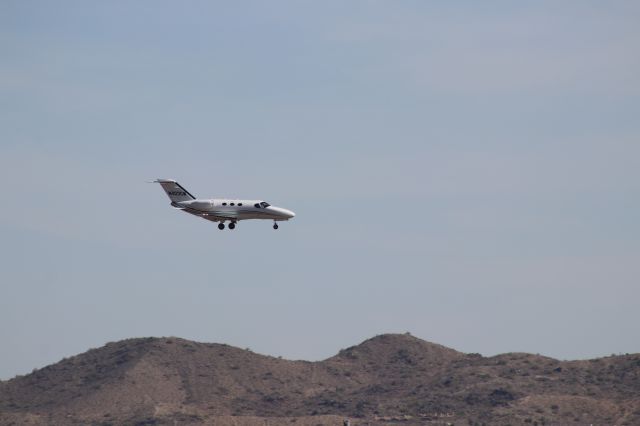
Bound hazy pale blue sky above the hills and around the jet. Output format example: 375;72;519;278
0;0;640;379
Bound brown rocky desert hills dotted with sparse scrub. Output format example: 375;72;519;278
0;334;640;426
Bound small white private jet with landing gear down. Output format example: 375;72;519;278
150;179;295;230
